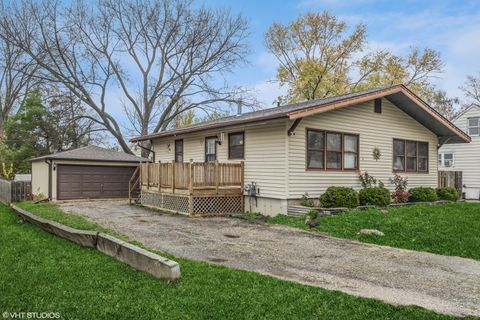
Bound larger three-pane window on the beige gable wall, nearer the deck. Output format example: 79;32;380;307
306;129;359;170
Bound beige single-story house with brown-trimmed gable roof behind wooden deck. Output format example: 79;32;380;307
132;85;470;215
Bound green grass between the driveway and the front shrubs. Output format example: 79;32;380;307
268;203;480;260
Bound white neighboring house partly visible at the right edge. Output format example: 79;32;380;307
438;105;480;200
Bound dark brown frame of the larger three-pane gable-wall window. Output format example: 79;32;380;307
305;128;360;172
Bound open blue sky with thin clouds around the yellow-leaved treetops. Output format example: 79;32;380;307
203;0;480;107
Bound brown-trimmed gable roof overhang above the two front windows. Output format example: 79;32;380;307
288;85;471;144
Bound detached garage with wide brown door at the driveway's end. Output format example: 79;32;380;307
31;146;149;200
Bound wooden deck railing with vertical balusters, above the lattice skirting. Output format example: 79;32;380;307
140;161;244;193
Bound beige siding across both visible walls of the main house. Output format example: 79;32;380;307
153;100;438;199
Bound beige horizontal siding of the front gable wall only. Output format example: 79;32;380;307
288;99;438;199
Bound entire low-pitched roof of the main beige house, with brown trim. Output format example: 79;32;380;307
130;85;470;144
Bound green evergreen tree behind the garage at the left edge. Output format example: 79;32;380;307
0;92;101;172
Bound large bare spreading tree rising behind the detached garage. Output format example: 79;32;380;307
0;0;253;153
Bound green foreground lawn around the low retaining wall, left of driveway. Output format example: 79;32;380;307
0;203;464;319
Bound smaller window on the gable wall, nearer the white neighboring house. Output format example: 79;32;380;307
393;139;428;172
